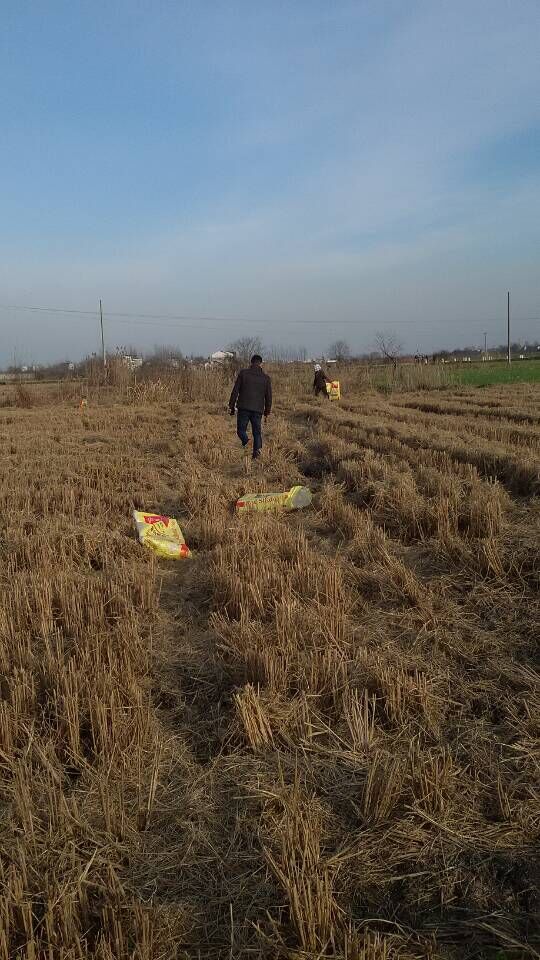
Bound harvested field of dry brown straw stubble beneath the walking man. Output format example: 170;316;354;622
0;386;540;960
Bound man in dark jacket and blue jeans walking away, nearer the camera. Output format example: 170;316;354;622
229;353;272;460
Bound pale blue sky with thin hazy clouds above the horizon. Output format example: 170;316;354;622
0;0;540;363
